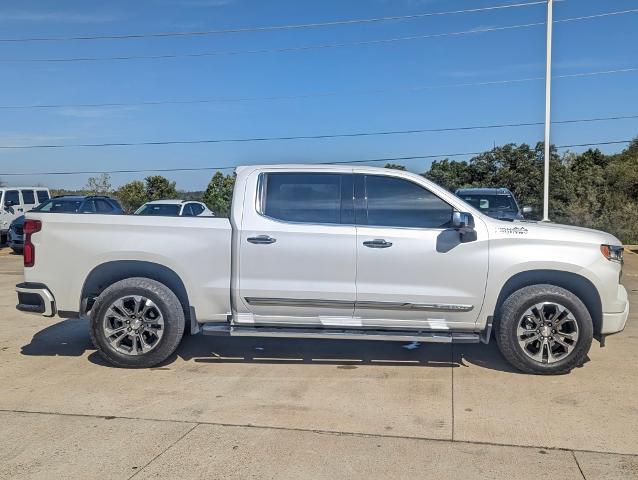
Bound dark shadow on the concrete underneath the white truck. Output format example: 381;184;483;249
21;318;544;374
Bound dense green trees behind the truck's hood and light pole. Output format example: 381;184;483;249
423;139;638;243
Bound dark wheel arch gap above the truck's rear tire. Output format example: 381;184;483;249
80;260;198;333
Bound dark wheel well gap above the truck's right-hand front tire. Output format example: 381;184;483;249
494;270;603;334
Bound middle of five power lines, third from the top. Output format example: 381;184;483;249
0;67;638;109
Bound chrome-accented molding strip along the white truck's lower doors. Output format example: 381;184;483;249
244;297;474;312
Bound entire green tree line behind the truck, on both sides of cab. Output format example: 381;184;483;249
51;138;638;243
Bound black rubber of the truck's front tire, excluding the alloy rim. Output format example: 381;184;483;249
497;285;593;374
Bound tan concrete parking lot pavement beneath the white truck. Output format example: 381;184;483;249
0;248;638;480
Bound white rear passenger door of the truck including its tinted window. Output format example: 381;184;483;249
235;170;357;326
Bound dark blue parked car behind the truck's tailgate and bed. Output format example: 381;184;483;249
7;195;124;253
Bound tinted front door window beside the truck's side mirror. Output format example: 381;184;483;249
366;175;453;228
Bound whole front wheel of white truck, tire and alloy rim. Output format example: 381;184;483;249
495;285;594;375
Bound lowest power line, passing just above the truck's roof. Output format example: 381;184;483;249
0;140;633;177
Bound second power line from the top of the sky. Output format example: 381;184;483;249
0;8;638;63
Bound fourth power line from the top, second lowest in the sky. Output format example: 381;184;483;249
0;114;638;150
